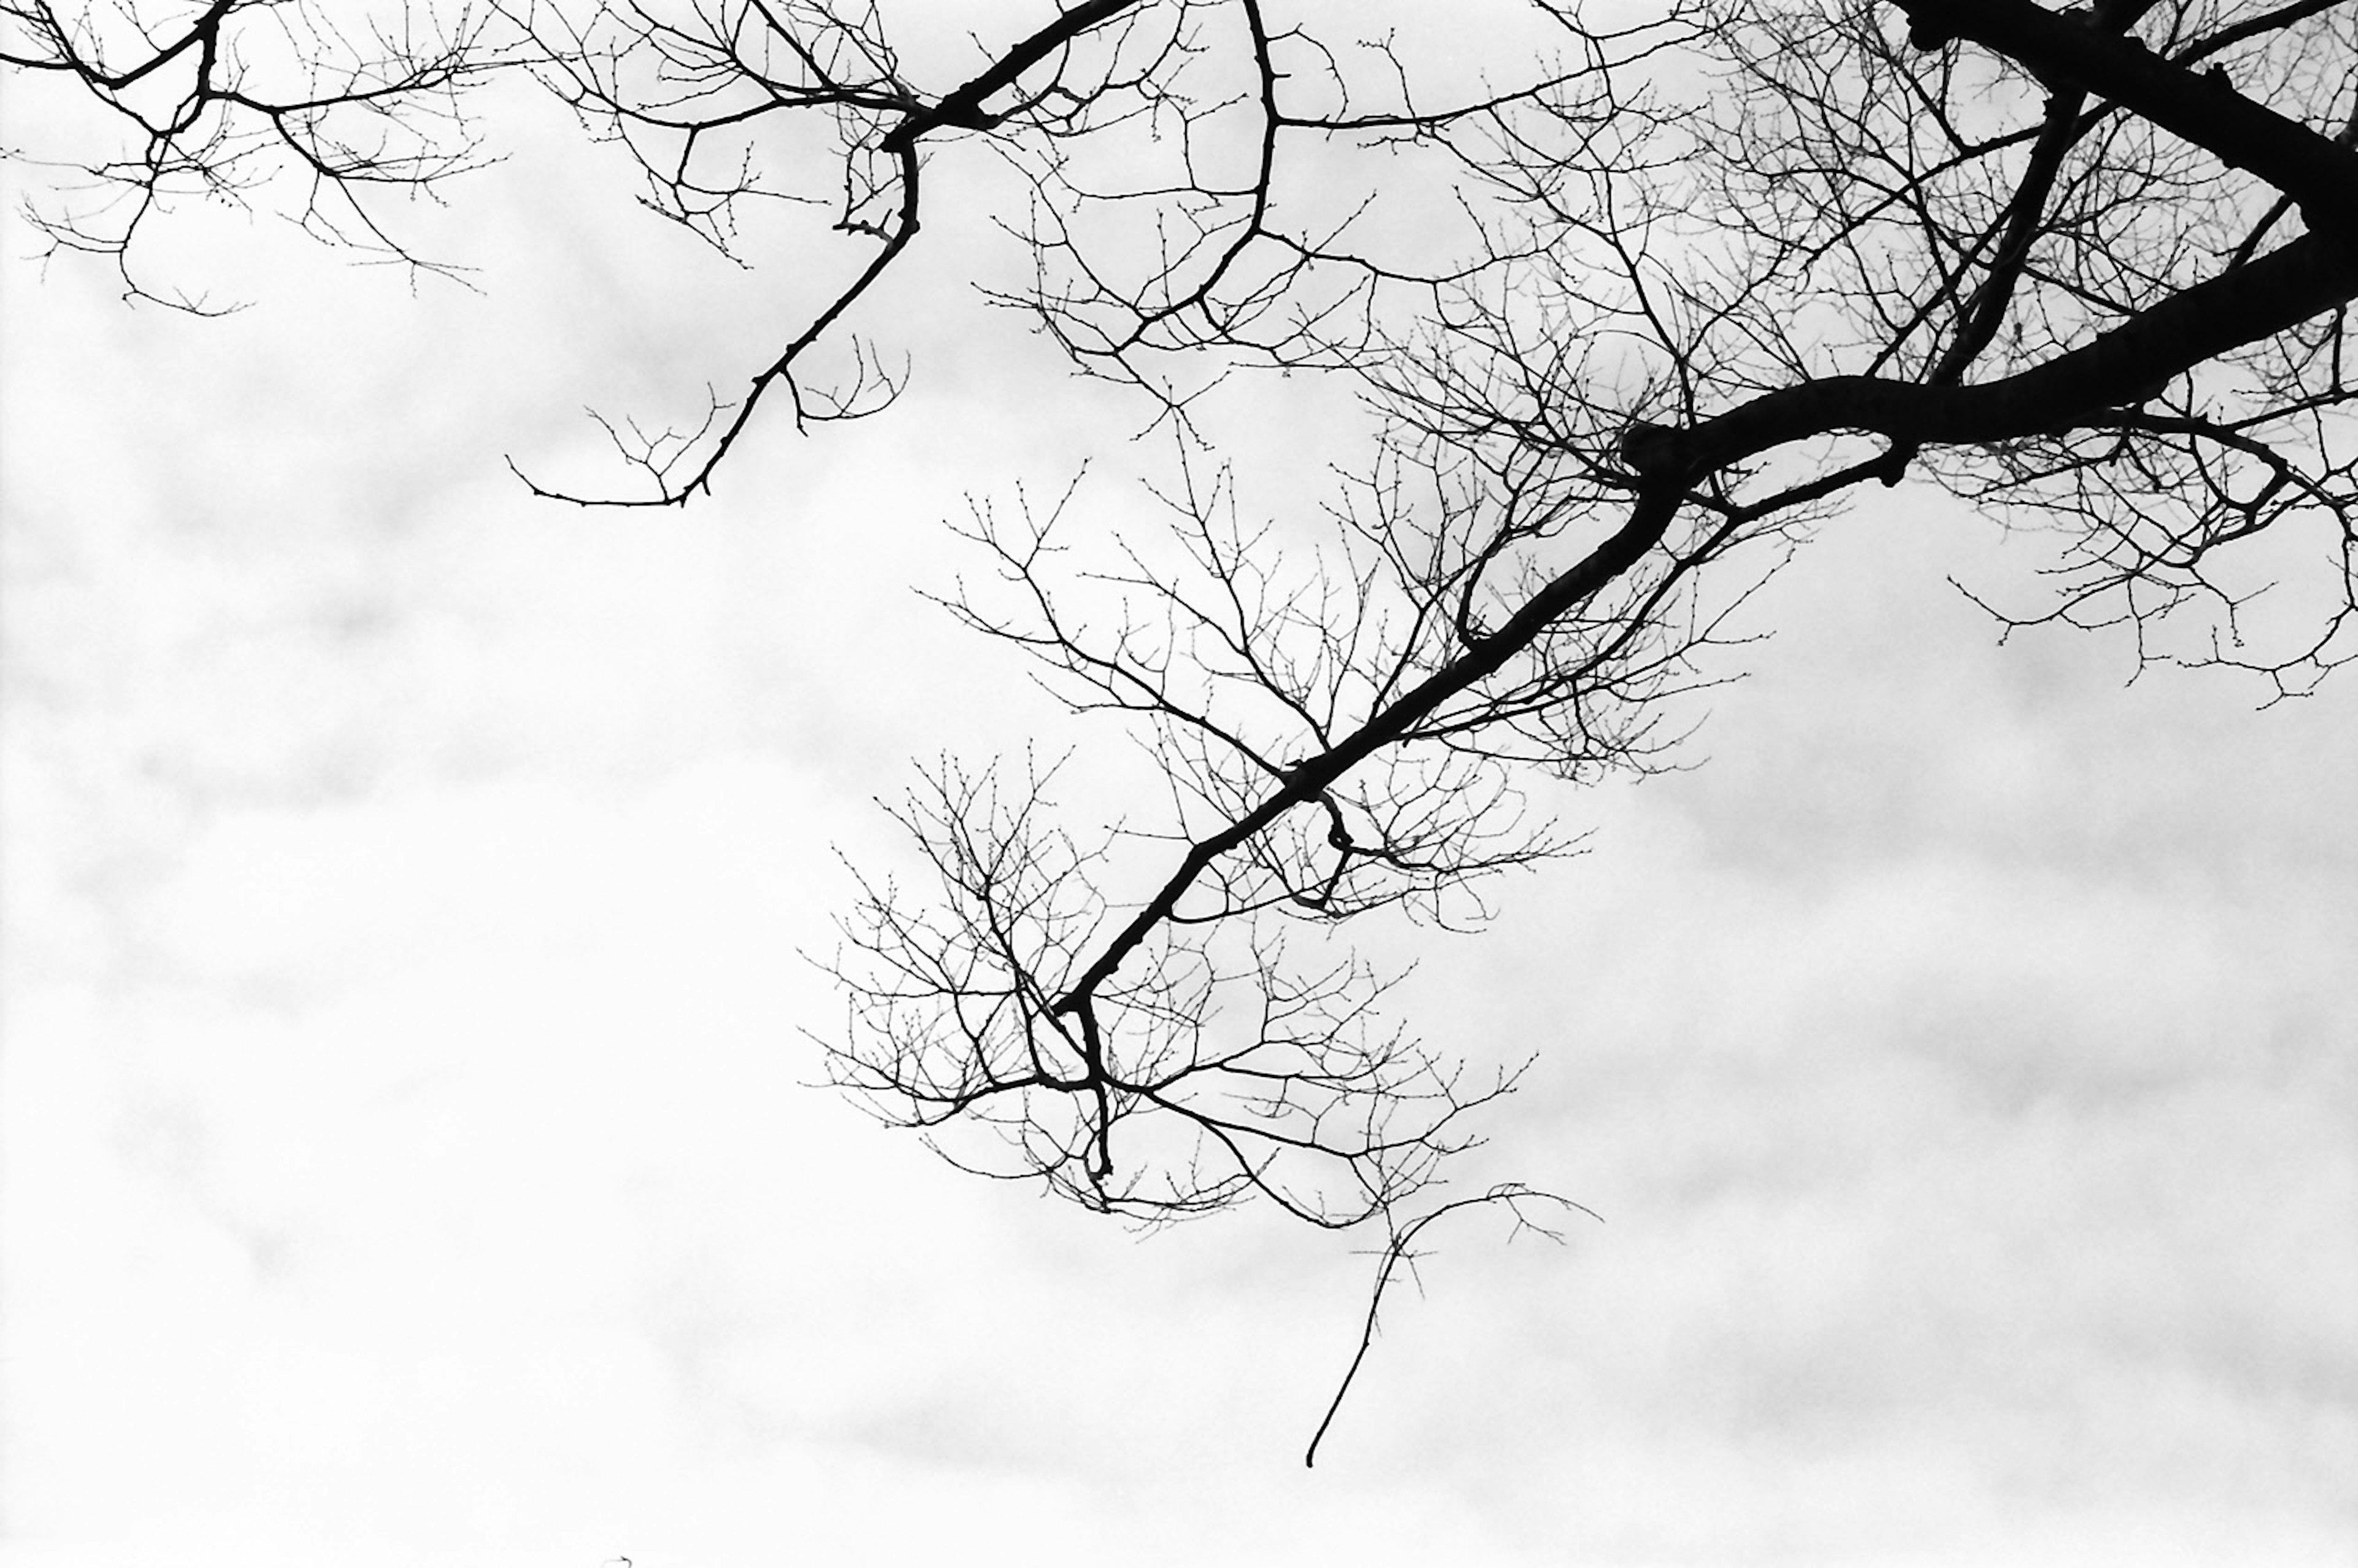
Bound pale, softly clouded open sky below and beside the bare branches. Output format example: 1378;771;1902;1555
0;18;2358;1568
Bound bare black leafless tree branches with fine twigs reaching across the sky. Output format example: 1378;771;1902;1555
0;0;2358;1443
